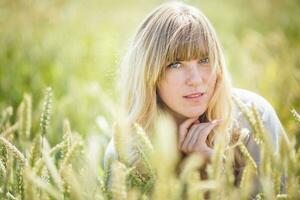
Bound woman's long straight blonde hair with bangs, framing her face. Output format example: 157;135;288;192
120;2;232;146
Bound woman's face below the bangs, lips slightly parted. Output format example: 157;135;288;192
158;58;217;121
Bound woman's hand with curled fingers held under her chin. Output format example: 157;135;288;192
178;118;222;158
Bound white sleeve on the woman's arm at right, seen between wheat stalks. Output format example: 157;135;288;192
234;90;287;197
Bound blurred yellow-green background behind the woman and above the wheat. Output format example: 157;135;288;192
0;0;300;143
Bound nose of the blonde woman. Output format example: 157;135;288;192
186;61;204;87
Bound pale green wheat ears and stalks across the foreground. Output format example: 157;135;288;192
0;88;300;200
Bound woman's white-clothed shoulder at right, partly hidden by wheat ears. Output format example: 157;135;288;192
231;88;287;194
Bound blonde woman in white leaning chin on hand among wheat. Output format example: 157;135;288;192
104;2;284;197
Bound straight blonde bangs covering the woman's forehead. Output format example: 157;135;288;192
164;19;210;66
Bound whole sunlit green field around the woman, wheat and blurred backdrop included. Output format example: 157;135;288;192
0;0;300;200
